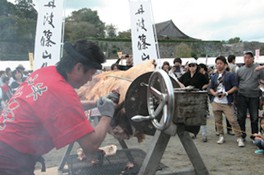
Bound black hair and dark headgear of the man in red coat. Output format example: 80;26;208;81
57;40;105;79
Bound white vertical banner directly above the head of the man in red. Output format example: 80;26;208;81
34;0;63;70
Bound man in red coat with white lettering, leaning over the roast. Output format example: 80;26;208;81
0;40;115;175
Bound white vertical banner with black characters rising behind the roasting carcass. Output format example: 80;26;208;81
129;0;158;65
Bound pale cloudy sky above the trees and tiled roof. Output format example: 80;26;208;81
7;0;264;42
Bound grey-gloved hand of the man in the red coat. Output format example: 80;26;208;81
96;97;115;118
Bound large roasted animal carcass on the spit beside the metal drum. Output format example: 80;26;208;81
77;60;155;142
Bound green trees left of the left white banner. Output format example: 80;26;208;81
0;0;37;42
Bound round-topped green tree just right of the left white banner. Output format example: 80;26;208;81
65;8;105;41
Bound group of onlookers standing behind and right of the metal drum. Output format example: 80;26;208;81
162;51;264;154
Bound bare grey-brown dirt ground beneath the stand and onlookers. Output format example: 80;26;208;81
36;111;264;175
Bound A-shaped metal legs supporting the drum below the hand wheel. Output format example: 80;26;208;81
138;125;209;175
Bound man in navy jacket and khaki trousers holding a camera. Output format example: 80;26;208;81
209;56;245;147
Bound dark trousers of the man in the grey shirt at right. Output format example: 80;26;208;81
237;93;259;138
